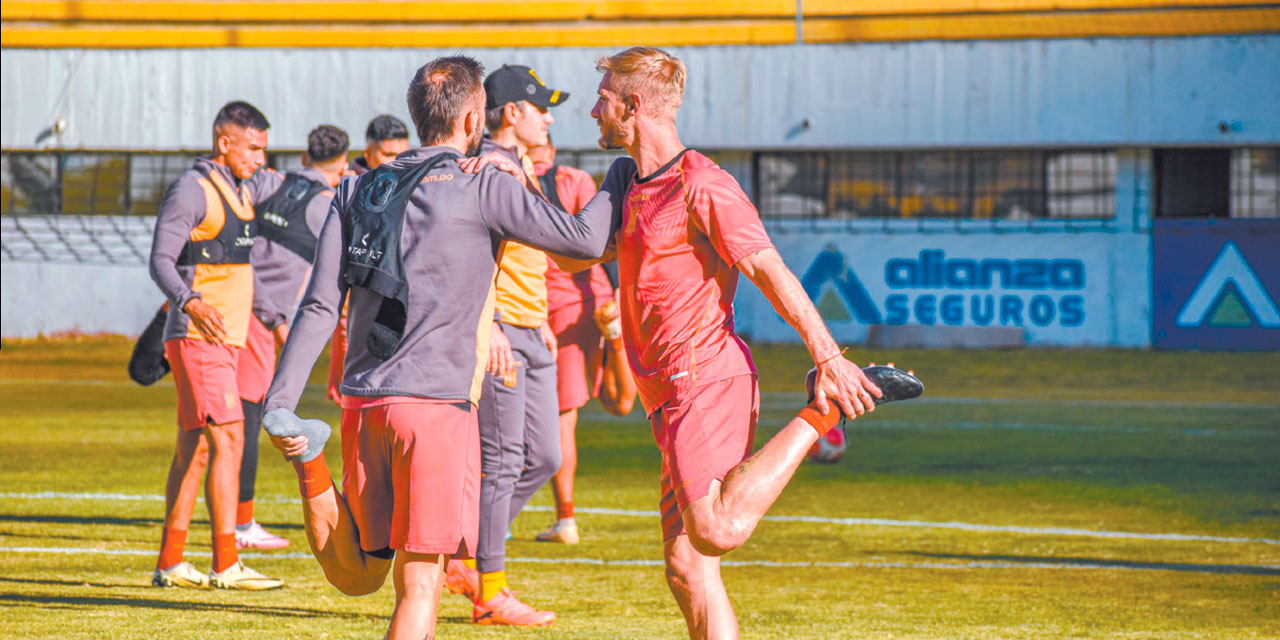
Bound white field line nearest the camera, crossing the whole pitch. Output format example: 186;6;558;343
0;547;1280;576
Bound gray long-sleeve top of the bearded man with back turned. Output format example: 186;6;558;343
265;146;625;411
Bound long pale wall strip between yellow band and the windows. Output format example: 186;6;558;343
0;35;1280;150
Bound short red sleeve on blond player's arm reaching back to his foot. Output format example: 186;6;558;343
685;168;773;265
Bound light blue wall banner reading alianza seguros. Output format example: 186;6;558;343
736;232;1151;347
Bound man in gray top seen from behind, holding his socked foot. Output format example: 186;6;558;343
264;56;621;637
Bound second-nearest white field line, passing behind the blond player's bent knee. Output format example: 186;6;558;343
0;492;1280;545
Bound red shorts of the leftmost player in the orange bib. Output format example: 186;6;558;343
164;338;244;431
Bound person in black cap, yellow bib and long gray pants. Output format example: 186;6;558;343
445;64;568;626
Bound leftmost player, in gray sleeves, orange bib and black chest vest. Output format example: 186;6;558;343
150;102;284;589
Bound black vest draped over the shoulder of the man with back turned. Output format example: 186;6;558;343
343;152;456;360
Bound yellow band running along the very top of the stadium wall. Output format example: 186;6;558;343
0;0;1280;49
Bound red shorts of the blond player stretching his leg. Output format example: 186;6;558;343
650;374;760;540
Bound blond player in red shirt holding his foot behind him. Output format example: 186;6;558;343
576;47;906;639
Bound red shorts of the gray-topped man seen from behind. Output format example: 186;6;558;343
342;396;480;557
